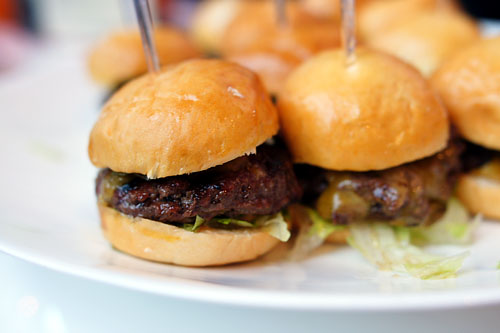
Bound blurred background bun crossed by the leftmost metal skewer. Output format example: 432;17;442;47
88;26;199;86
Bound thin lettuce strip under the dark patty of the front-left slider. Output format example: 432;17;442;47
184;212;290;242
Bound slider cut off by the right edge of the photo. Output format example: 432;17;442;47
432;37;500;219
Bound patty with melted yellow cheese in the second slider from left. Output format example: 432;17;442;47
296;140;463;226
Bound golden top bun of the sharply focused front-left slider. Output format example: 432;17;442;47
89;59;279;178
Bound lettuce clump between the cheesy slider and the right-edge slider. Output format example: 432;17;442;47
410;198;481;245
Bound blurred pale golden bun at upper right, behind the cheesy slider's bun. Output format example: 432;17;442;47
368;11;480;76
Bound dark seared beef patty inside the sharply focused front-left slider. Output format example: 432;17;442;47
96;144;301;223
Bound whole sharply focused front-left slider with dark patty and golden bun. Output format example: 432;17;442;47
89;60;301;266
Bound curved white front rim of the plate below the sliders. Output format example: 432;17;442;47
0;242;500;312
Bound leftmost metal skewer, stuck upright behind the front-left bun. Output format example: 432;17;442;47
134;0;160;73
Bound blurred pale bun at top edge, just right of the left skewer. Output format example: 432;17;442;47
190;0;242;53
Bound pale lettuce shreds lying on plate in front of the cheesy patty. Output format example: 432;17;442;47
348;223;469;279
